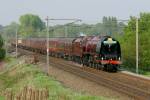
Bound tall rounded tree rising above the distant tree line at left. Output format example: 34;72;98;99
19;14;45;36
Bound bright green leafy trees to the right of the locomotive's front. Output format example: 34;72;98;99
120;13;150;71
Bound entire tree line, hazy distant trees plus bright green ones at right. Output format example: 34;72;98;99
0;13;150;71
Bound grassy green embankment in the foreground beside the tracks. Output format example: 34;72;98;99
0;58;110;100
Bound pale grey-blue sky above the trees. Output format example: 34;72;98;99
0;0;150;25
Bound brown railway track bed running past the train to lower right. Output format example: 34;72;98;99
16;50;150;100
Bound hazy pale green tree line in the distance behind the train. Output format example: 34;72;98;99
0;14;125;37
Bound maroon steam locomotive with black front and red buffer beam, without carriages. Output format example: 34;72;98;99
73;36;121;71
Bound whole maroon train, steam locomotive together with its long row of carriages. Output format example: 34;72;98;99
12;36;121;71
